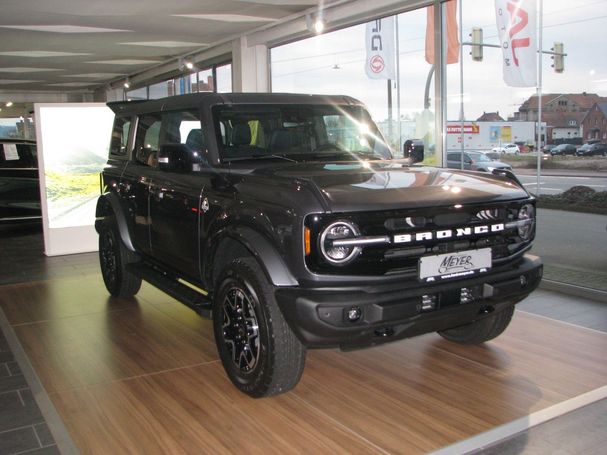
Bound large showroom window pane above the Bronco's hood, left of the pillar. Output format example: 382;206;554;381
271;4;436;162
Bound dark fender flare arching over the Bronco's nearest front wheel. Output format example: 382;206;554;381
207;226;298;286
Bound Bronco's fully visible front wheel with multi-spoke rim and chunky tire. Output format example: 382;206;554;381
213;258;306;398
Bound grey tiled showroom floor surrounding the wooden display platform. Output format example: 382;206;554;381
0;229;607;454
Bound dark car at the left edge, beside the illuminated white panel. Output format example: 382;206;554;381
0;139;42;223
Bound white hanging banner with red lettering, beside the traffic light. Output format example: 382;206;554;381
495;0;538;87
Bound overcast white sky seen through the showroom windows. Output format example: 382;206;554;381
272;0;607;121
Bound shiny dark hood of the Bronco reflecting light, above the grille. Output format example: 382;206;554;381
237;161;529;212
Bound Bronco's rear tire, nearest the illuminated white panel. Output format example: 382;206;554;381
99;217;141;298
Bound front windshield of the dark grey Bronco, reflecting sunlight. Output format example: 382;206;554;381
214;105;392;162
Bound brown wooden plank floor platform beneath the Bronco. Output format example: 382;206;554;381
0;274;607;454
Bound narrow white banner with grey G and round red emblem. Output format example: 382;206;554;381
365;18;396;79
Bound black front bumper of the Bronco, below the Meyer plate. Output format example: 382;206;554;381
275;254;543;349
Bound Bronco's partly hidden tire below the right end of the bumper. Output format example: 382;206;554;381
438;305;514;344
